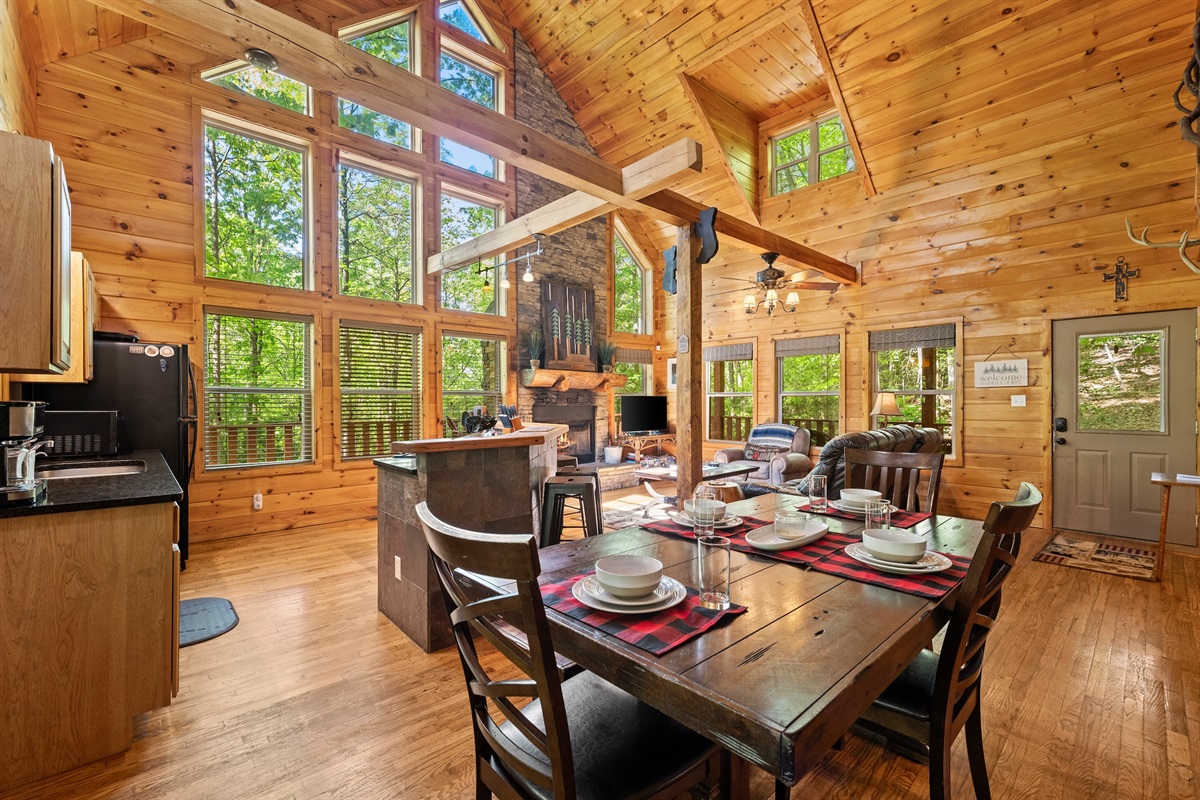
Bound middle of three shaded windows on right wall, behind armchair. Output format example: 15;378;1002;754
775;336;841;445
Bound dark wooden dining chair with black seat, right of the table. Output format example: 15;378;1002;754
858;483;1042;800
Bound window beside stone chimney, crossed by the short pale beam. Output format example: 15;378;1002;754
442;194;505;314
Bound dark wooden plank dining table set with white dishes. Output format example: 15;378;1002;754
525;494;983;798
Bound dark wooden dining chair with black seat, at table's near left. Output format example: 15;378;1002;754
416;503;730;800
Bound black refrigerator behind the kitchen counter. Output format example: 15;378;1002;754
32;339;196;564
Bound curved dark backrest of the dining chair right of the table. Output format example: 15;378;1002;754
932;483;1042;741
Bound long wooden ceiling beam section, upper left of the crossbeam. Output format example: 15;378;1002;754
95;0;625;201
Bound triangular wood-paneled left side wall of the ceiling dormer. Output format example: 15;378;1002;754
679;73;758;223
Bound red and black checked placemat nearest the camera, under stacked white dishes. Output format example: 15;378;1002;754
541;573;746;656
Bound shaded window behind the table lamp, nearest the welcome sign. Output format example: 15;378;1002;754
868;325;956;453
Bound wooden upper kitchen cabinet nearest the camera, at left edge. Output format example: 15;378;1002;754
0;132;73;374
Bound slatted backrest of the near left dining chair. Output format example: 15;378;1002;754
416;503;575;800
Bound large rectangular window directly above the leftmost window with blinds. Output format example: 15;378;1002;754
204;125;307;289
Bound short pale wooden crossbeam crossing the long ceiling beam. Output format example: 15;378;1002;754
426;139;702;273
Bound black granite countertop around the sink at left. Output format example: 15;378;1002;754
0;450;184;518
